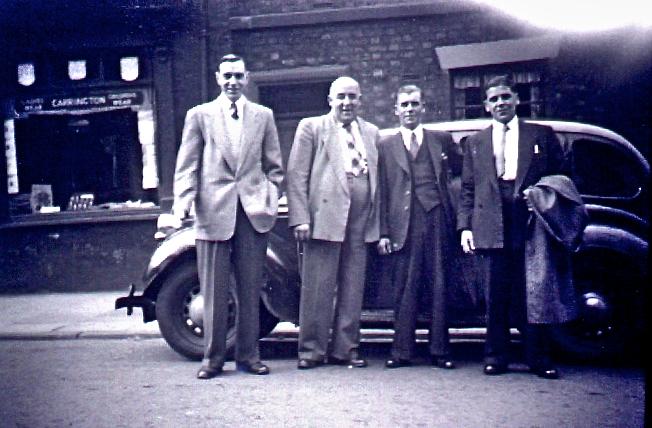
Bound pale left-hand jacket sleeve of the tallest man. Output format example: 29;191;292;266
173;108;204;213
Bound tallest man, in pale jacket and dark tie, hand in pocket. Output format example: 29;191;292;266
173;55;283;379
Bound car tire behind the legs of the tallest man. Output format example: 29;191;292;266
156;260;278;361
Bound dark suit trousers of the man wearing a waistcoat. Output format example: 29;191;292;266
392;202;449;360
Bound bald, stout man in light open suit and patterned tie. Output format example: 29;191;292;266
287;77;380;369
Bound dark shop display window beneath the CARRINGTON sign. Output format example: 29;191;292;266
10;109;151;214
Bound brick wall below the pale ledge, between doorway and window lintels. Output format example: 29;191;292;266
232;10;523;127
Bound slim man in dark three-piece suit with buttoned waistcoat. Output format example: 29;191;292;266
378;85;457;369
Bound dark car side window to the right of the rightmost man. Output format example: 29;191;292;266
570;136;645;198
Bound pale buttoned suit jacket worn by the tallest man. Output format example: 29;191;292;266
174;99;283;241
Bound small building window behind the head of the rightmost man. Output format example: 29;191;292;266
452;67;544;119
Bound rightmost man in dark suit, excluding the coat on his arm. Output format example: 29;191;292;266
457;76;564;379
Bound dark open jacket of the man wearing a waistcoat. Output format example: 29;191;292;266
378;130;459;251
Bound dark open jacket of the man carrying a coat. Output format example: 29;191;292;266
457;120;564;249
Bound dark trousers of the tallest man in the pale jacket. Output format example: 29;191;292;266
197;203;267;368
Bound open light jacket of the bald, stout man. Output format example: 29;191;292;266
287;114;380;242
